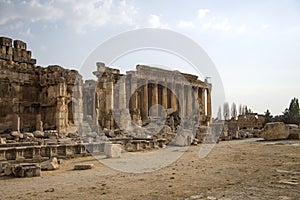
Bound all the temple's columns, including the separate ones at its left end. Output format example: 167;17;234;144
97;78;212;127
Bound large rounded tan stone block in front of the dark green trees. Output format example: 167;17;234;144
260;122;290;140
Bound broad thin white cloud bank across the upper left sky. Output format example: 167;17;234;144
0;0;137;33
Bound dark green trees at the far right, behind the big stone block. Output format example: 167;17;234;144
265;97;300;124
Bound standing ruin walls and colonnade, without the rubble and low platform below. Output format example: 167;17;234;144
0;37;212;139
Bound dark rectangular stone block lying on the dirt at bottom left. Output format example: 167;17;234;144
12;163;41;177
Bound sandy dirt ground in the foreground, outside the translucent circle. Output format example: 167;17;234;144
0;139;300;200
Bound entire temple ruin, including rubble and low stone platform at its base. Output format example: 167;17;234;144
0;37;212;167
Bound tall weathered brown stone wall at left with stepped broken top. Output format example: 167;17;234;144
0;37;82;133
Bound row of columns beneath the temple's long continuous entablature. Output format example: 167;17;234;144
126;80;212;120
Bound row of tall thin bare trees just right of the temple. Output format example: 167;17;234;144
217;102;252;120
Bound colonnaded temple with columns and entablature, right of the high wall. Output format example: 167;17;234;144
92;63;212;129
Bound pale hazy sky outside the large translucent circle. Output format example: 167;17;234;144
0;0;300;114
